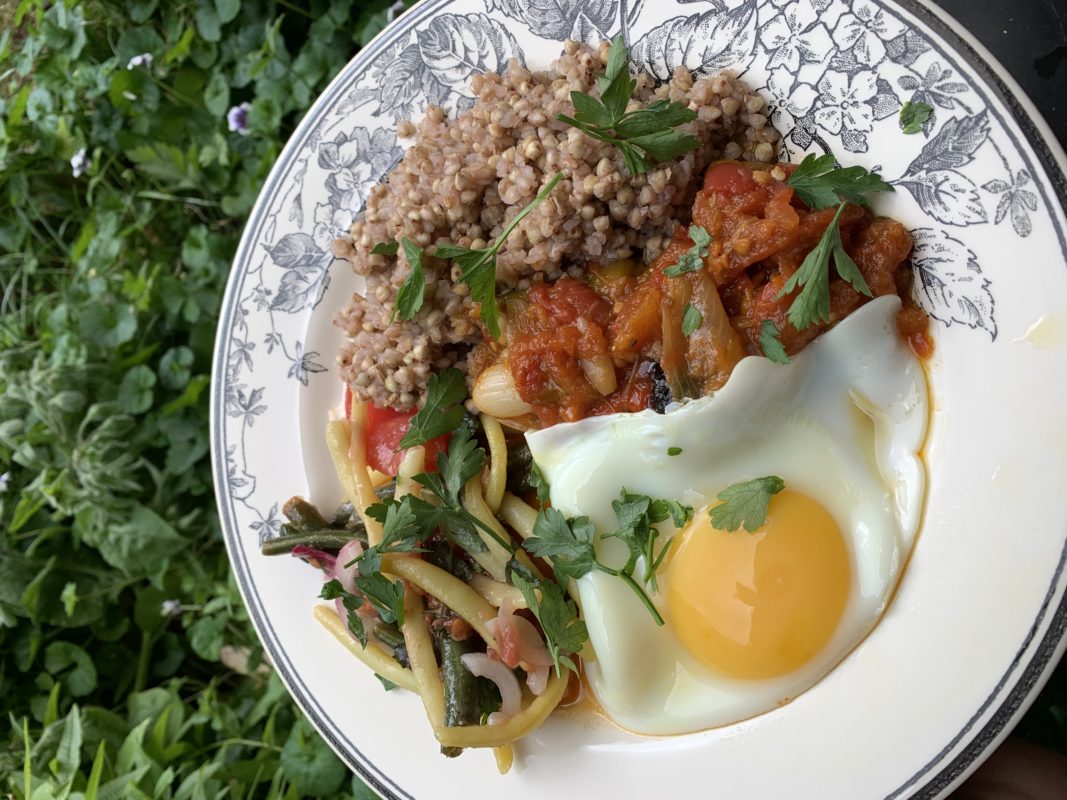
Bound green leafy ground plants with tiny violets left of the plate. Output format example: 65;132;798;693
0;0;1067;800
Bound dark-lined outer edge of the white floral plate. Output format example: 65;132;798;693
211;0;1067;800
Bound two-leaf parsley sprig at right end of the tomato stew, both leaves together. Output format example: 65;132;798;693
775;153;893;331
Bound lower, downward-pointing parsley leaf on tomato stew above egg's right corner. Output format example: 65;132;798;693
776;203;871;330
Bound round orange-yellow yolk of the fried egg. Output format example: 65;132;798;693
668;490;851;678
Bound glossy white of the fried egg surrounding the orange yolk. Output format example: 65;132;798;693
527;297;928;734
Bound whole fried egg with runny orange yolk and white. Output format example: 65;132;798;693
527;297;928;734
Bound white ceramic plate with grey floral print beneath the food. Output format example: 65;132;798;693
211;0;1067;800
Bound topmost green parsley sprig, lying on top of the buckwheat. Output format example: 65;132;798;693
556;36;700;175
